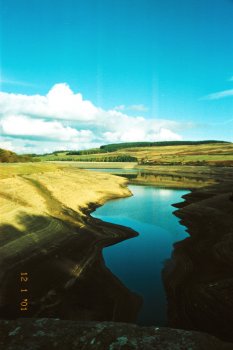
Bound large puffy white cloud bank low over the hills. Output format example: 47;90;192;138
0;83;182;153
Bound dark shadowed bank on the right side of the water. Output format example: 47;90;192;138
164;173;233;341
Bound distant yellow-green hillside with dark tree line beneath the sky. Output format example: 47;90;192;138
37;141;233;166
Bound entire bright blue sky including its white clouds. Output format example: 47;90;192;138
0;0;233;152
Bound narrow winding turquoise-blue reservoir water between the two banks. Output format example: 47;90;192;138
92;185;188;326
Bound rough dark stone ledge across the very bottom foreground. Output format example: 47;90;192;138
0;319;233;350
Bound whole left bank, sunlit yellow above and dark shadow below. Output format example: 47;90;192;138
0;164;140;321
